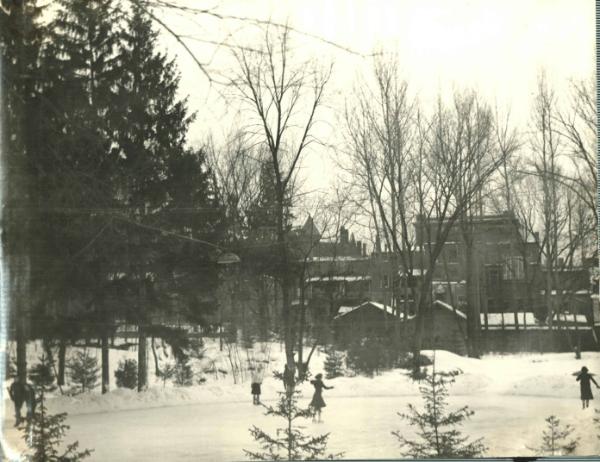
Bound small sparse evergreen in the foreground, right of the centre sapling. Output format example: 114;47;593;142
392;364;487;458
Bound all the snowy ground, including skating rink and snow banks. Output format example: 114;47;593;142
3;344;600;461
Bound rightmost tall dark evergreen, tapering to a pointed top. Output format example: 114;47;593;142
110;4;220;390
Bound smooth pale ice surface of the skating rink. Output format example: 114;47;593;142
4;395;600;462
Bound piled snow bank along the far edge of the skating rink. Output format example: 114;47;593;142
5;340;600;414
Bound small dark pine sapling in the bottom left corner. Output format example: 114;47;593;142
21;387;92;462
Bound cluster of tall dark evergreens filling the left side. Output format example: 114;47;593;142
0;0;223;391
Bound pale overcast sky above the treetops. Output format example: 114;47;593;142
155;0;595;193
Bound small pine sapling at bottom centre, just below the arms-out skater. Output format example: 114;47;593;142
244;390;343;460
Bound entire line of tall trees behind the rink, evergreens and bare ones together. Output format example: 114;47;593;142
0;0;597;391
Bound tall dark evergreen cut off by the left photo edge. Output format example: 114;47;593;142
0;0;45;381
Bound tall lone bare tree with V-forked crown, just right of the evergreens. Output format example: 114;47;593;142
231;28;331;390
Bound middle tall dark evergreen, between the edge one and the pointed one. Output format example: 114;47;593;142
37;0;121;398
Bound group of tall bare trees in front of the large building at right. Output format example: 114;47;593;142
340;55;597;358
